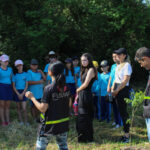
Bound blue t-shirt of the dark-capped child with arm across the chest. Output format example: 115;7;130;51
28;70;44;99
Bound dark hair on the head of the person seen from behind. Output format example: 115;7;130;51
48;62;66;89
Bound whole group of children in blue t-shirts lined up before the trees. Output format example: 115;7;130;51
0;51;121;127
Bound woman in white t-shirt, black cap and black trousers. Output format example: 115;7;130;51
112;48;132;143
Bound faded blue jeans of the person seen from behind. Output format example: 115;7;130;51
36;132;68;150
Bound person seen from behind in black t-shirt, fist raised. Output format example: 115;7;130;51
26;62;70;150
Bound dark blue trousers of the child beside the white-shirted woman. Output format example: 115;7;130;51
112;99;123;126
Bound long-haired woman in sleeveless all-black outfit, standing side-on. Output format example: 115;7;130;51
77;53;97;142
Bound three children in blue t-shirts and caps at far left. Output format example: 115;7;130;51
0;54;46;126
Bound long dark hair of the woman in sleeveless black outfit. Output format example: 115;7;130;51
81;53;97;80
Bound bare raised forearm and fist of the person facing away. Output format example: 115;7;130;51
25;91;48;113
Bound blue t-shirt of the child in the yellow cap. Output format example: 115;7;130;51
92;72;101;96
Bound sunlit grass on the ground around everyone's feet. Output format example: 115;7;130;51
0;100;150;150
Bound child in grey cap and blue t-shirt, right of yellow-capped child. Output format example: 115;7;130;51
100;60;111;123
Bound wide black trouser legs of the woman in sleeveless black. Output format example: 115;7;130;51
76;114;93;142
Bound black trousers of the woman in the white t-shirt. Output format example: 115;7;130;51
116;86;130;133
